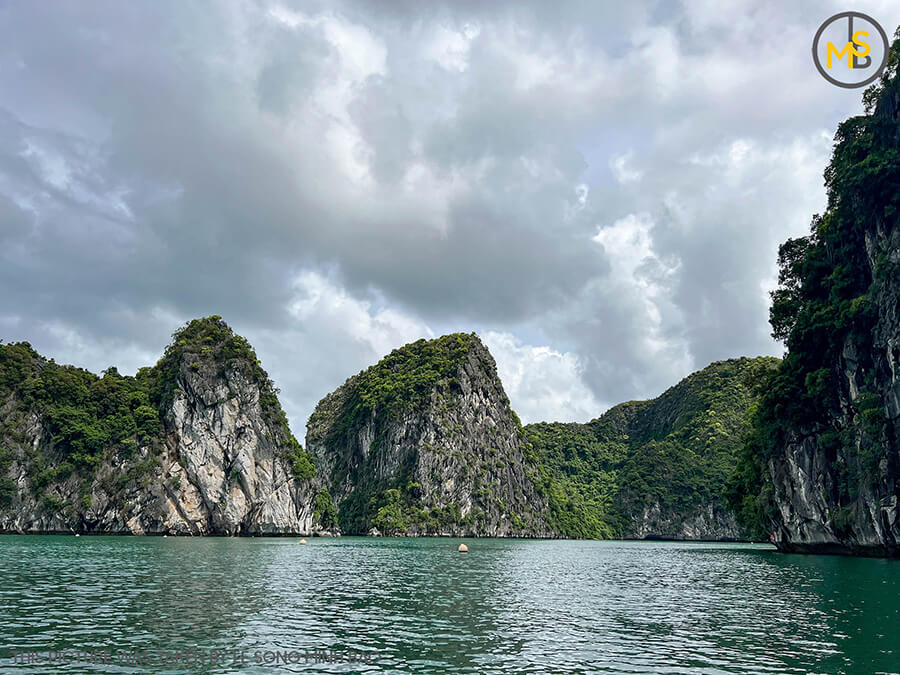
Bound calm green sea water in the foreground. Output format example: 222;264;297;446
0;536;900;673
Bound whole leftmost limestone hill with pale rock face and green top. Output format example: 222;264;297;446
0;317;318;535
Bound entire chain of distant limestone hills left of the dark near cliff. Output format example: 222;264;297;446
0;316;778;539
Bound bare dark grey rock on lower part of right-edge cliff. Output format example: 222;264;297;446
768;195;900;556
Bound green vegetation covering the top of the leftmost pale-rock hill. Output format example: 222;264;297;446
0;316;315;515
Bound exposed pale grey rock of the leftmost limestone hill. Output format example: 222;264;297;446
0;324;316;535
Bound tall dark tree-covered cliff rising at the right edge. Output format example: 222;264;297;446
732;33;900;555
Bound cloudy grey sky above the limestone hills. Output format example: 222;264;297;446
0;0;900;436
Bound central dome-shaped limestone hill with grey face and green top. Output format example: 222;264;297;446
306;334;552;537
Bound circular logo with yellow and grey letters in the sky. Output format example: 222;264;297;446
813;12;889;89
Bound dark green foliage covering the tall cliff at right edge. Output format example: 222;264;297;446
729;35;900;533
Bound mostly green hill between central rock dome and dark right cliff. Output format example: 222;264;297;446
525;357;778;540
